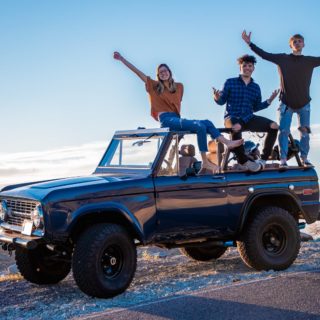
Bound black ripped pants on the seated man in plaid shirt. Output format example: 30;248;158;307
225;115;278;164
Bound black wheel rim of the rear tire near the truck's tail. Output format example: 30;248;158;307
262;225;287;256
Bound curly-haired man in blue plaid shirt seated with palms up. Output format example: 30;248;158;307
213;55;279;172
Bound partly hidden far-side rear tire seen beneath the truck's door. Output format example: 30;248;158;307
180;246;227;261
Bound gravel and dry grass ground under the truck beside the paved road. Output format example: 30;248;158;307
0;222;320;319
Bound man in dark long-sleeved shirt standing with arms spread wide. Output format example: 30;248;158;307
242;30;320;167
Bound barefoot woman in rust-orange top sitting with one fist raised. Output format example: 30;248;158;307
113;52;243;173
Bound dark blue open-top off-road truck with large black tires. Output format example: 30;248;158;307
0;128;319;298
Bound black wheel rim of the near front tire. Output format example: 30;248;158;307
101;245;123;279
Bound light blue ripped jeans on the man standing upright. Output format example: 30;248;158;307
279;103;310;159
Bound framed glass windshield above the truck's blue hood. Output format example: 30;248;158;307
99;134;164;169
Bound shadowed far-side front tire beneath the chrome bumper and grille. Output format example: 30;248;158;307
15;246;71;284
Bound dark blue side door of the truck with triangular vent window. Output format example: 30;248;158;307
154;136;234;238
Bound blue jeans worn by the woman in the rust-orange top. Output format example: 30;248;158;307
159;112;221;152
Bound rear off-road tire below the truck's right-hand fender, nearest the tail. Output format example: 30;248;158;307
237;207;300;270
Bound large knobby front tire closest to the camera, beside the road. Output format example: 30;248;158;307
72;223;137;298
